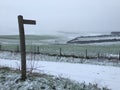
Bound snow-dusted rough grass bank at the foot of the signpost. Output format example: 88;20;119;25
0;67;109;90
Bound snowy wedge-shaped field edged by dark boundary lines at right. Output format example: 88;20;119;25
67;35;120;44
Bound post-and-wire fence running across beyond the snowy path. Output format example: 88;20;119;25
0;44;120;60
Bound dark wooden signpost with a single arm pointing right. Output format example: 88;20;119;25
18;15;36;80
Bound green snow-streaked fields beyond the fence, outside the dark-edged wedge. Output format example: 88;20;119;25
0;34;120;58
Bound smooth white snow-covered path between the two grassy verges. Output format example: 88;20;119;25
0;59;120;90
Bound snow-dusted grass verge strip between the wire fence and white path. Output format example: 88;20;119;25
0;51;120;67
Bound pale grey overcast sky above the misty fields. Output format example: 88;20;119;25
0;0;120;34
